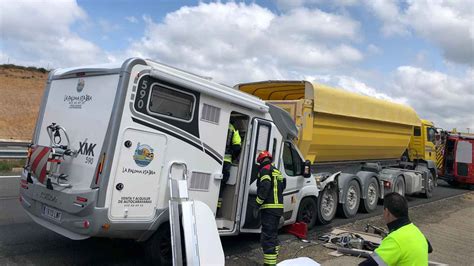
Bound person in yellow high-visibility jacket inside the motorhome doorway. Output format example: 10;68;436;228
217;120;242;212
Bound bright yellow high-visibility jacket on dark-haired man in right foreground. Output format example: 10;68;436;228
372;217;429;265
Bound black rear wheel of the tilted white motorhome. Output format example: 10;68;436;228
146;224;173;266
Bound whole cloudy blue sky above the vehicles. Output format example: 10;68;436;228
0;0;474;131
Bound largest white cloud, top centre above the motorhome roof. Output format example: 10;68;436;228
128;2;363;84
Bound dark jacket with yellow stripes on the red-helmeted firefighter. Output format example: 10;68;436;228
256;163;286;216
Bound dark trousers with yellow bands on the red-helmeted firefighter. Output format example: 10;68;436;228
260;209;280;265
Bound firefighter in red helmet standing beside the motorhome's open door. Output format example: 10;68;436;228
256;151;286;265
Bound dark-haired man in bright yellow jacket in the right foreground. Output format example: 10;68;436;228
359;192;433;265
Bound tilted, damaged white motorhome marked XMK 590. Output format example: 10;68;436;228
20;58;318;262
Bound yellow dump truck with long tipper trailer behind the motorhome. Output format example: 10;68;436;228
236;81;436;224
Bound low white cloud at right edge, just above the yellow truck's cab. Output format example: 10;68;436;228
394;66;474;131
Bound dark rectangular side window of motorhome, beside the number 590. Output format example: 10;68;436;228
149;84;194;121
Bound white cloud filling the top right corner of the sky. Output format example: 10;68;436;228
365;0;474;66
